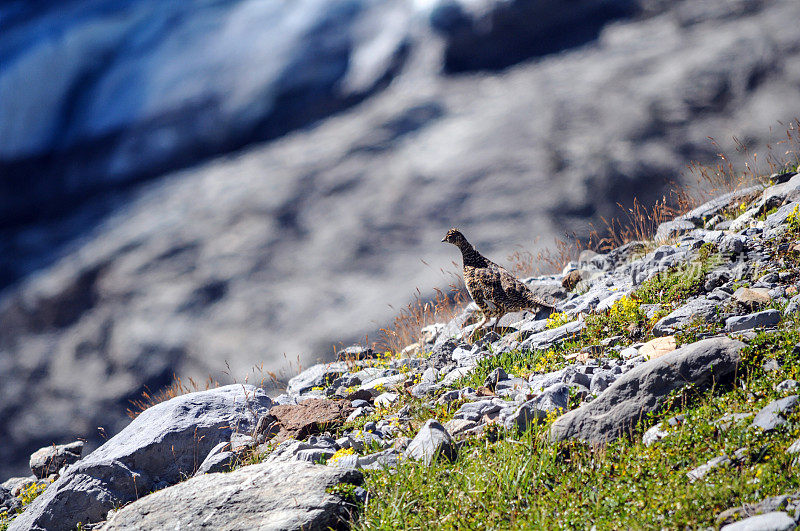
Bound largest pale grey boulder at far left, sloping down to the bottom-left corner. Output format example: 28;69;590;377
9;385;272;531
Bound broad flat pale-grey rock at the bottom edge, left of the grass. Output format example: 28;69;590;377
101;461;363;531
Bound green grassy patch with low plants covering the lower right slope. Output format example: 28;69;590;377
357;323;800;529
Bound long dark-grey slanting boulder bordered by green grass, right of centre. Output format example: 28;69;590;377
550;337;744;443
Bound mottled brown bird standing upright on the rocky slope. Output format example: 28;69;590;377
442;228;555;340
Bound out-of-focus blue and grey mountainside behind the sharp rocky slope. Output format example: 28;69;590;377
0;0;800;479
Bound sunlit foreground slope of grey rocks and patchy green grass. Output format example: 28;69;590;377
2;173;800;531
